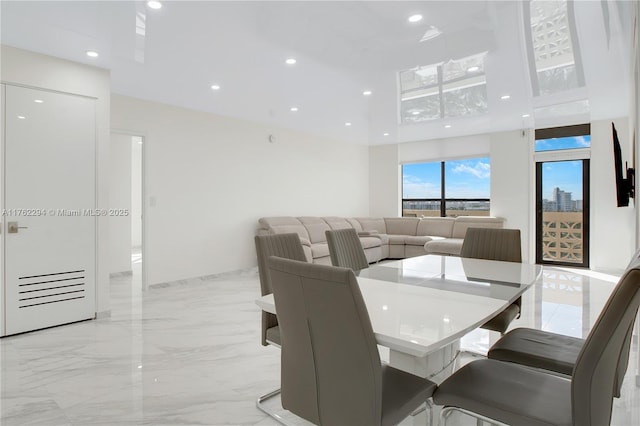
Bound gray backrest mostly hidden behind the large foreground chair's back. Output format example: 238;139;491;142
255;233;306;346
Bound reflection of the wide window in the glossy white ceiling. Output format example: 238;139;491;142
399;53;487;123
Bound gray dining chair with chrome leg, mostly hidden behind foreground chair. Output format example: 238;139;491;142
255;233;306;416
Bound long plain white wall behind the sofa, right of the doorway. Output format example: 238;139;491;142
111;95;369;284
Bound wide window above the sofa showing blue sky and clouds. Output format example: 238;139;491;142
402;157;491;217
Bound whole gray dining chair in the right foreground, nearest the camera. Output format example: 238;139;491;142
433;251;640;426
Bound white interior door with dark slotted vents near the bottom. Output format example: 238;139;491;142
2;85;96;335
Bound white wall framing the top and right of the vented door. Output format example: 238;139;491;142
0;46;111;315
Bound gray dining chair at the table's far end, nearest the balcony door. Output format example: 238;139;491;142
460;228;522;334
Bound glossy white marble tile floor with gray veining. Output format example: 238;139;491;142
0;268;640;426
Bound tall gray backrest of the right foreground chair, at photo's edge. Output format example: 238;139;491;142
571;252;640;426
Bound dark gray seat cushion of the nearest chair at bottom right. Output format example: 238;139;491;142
433;359;572;426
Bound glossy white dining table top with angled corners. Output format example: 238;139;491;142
256;255;542;357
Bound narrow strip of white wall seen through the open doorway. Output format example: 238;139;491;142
109;133;131;273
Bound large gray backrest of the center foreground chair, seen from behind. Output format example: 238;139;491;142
269;257;382;425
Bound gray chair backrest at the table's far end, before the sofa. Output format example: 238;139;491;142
460;228;522;262
